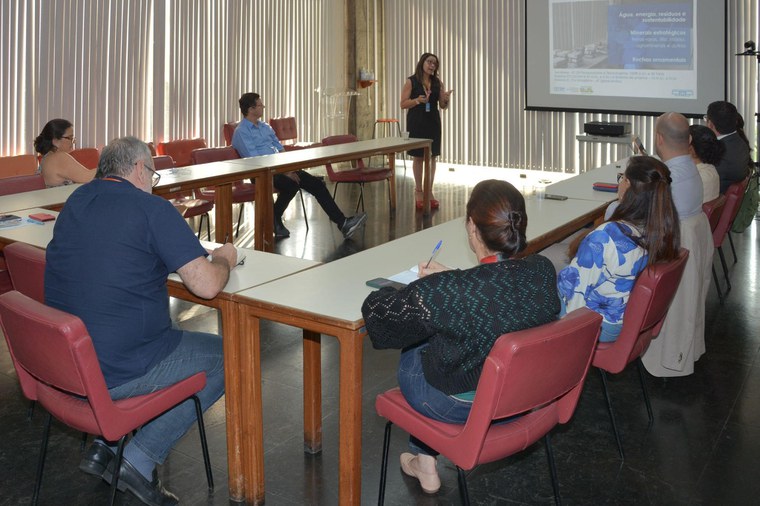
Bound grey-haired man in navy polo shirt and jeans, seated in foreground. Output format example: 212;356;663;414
45;137;237;505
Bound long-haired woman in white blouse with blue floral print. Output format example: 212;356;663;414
557;156;680;342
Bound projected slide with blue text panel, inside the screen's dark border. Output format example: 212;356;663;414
549;0;697;98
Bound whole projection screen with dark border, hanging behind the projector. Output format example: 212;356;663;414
525;0;725;115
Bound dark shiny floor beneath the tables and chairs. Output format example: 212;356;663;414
0;172;760;506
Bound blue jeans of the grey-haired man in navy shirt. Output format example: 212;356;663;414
109;332;224;464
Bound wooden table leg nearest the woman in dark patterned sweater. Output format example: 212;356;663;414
337;332;365;506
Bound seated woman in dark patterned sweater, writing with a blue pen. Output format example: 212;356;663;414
362;179;560;493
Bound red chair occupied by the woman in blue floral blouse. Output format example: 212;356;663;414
592;248;689;459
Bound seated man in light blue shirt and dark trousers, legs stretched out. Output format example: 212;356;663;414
232;93;367;239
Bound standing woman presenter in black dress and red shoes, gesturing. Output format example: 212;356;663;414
400;53;454;209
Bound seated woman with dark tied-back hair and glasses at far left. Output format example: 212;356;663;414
34;118;95;187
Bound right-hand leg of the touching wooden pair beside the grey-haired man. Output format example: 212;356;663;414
239;307;264;504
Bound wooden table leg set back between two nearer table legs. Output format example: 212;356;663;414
303;330;322;454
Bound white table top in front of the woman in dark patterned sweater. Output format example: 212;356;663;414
237;198;599;322
